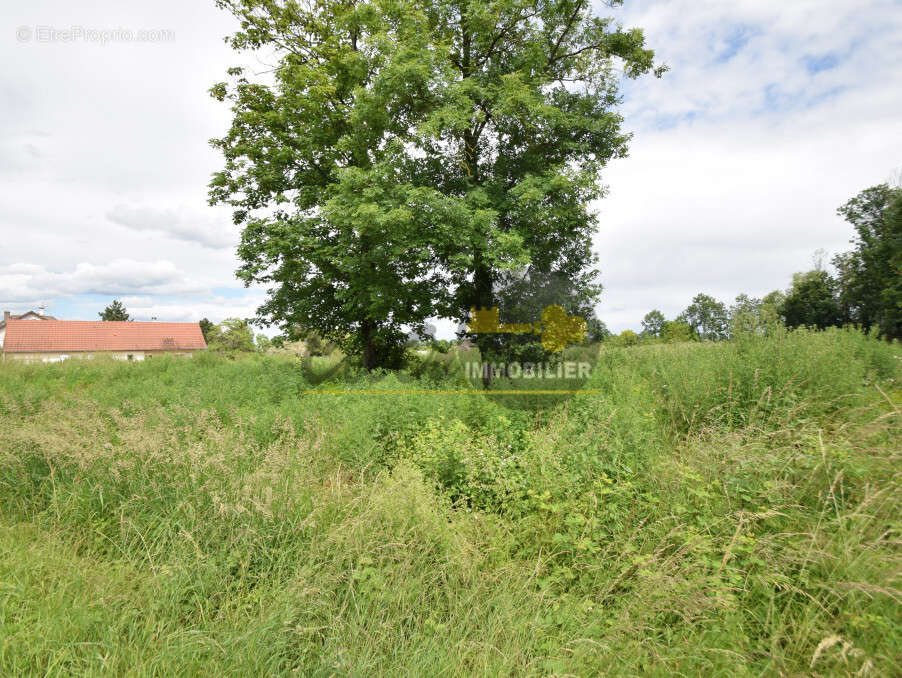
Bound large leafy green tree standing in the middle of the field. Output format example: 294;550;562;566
210;0;661;367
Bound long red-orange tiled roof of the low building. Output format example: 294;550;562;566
3;319;207;353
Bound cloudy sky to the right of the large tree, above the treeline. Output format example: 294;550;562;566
595;0;902;331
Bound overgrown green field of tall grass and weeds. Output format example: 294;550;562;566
0;330;902;676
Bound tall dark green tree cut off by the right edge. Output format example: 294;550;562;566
833;184;902;338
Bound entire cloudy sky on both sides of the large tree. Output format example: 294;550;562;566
0;0;902;331
